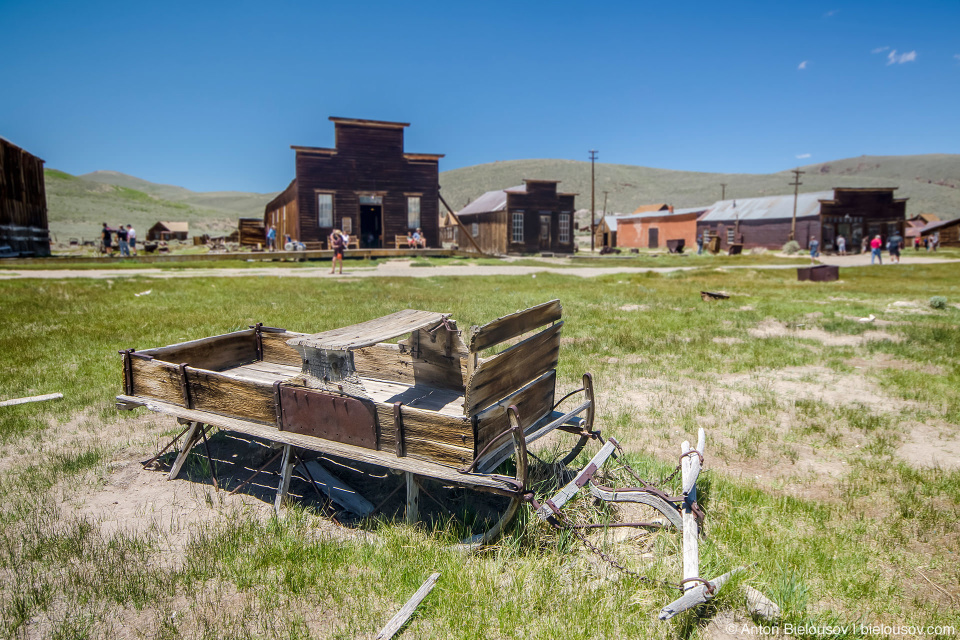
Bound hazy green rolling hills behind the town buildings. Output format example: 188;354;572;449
46;154;960;241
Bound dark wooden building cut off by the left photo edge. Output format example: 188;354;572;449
0;138;50;256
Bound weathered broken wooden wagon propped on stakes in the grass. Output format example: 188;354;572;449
117;300;596;543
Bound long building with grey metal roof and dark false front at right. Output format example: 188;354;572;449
697;187;907;253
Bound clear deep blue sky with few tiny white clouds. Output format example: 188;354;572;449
0;0;960;192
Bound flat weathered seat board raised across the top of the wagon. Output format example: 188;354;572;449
287;309;449;351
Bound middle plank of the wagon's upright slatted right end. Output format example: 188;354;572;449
464;321;563;416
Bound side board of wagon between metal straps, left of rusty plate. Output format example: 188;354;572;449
187;367;277;424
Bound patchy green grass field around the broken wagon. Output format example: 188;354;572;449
0;259;960;638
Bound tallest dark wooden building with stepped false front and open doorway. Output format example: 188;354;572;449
264;118;443;249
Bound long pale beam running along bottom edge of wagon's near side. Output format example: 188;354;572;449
123;395;515;497
